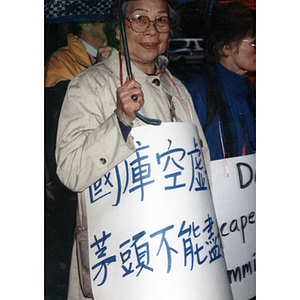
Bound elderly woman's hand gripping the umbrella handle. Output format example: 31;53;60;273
117;78;144;125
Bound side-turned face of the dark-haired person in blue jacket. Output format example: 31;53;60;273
220;37;256;75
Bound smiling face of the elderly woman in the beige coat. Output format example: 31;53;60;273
125;0;169;73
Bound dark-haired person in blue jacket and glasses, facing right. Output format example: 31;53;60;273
185;3;256;160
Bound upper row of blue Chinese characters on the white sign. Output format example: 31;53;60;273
89;138;208;206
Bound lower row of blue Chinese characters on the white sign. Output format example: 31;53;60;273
90;215;222;286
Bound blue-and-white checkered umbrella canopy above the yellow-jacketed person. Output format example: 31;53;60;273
44;0;112;23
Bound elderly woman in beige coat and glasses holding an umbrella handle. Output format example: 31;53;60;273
56;0;210;300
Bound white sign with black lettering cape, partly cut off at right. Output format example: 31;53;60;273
211;154;256;300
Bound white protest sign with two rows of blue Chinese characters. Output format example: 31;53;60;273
85;123;232;300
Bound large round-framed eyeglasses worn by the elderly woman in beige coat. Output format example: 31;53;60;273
125;16;171;33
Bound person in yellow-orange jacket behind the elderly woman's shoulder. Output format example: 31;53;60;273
44;12;111;198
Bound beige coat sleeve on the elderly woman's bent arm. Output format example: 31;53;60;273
56;73;135;192
